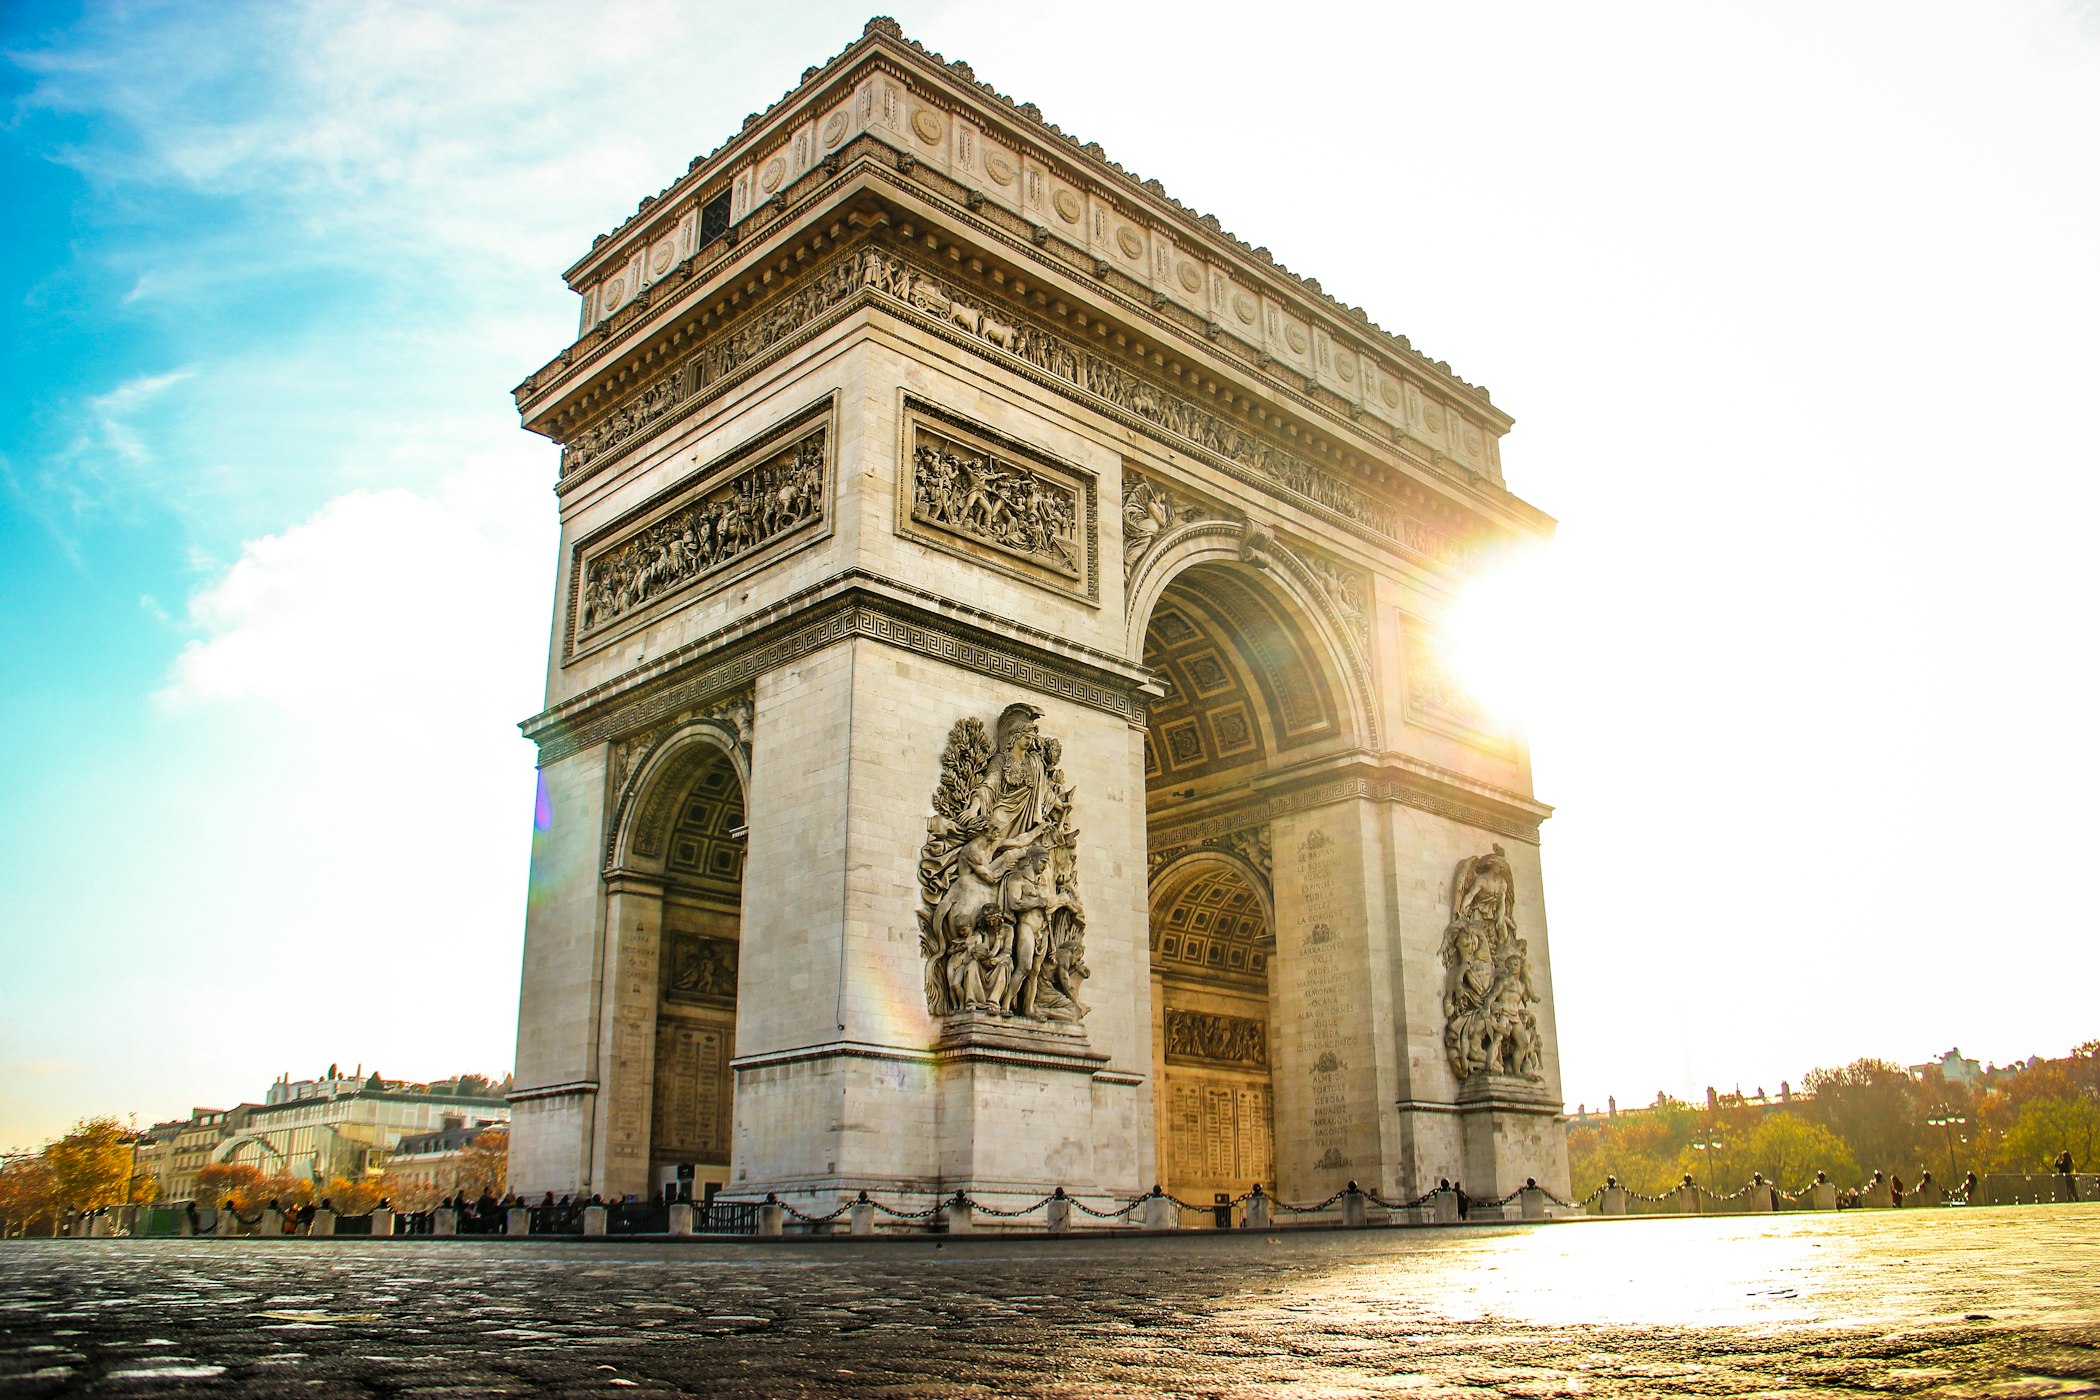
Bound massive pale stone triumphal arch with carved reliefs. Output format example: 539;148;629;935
510;19;1567;1207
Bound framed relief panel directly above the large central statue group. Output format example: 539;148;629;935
897;397;1100;602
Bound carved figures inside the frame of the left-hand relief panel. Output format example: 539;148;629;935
582;432;823;630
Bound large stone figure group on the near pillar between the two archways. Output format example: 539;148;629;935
920;705;1088;1020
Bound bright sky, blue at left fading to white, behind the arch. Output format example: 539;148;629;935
0;0;2100;1146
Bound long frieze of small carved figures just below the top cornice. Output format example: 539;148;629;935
561;246;1474;569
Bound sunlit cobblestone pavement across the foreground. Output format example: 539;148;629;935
0;1205;2100;1400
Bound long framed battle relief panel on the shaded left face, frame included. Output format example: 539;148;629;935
567;397;832;657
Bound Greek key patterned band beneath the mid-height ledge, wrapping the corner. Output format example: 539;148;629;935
519;596;1145;764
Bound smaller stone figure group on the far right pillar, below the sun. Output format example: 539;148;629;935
1443;844;1546;1079
